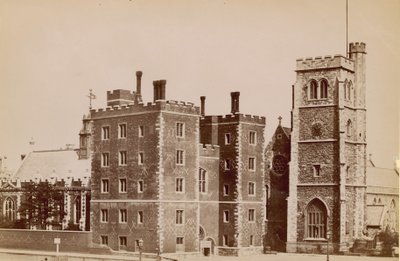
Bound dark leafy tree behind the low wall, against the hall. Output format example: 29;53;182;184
18;181;65;229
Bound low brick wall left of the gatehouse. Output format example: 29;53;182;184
0;229;92;252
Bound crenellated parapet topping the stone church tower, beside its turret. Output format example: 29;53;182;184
295;54;354;72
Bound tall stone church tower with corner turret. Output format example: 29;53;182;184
287;43;367;252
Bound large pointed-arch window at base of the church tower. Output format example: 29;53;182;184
306;199;327;238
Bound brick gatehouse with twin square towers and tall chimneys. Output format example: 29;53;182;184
90;72;265;254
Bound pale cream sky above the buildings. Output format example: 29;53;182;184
0;0;400;170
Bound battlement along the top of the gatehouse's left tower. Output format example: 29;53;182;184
90;100;200;119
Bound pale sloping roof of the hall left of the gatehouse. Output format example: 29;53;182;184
13;149;91;180
